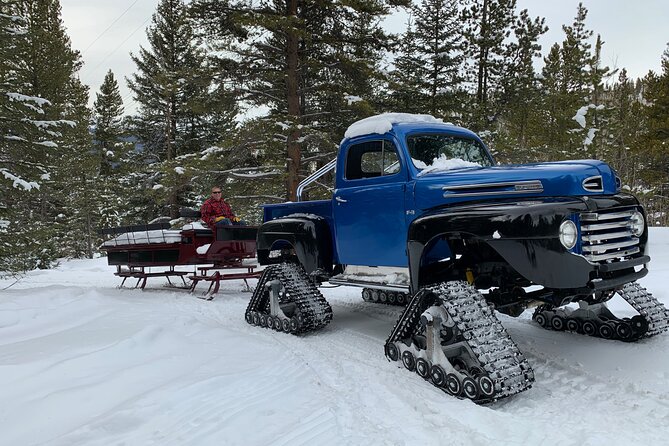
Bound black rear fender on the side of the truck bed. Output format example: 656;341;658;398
256;215;333;276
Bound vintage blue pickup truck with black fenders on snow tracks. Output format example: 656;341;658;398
246;114;669;403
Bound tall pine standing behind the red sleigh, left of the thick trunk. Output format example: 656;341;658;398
128;0;236;217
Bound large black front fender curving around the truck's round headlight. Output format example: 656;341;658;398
407;194;647;292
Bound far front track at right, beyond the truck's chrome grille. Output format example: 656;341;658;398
532;282;669;342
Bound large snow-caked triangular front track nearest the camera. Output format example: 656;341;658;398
385;282;534;403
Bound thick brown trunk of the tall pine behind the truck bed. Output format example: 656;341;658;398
286;0;302;201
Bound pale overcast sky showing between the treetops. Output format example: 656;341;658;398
61;0;669;114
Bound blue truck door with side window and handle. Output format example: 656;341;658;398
332;139;407;267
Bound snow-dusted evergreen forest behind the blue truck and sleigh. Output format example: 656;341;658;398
0;0;669;272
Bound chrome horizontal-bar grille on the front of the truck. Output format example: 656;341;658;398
580;209;639;262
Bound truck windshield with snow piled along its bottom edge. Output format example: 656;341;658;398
407;134;492;173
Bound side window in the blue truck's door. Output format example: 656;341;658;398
346;140;400;180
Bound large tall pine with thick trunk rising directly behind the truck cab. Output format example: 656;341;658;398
189;0;403;200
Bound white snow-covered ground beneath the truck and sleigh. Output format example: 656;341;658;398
0;228;669;446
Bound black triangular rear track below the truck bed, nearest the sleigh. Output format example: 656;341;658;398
245;263;332;334
